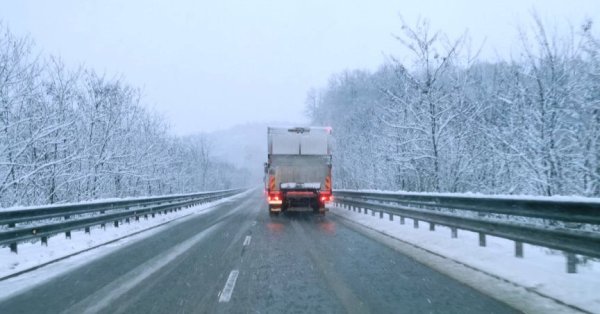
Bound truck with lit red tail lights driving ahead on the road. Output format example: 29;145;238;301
264;127;333;215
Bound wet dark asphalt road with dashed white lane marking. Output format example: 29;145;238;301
0;192;516;313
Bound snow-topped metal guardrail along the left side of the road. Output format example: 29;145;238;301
0;189;244;253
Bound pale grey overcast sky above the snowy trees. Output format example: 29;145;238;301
0;0;600;134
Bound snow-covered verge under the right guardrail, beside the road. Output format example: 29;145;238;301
330;207;600;313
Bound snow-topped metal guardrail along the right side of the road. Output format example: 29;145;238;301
334;190;600;273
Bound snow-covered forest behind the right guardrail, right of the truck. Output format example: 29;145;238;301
306;14;600;197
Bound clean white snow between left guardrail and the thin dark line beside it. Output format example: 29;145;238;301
0;194;246;280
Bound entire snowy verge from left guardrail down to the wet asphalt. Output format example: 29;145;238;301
0;192;248;299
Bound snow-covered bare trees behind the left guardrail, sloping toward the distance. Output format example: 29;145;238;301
0;24;248;207
